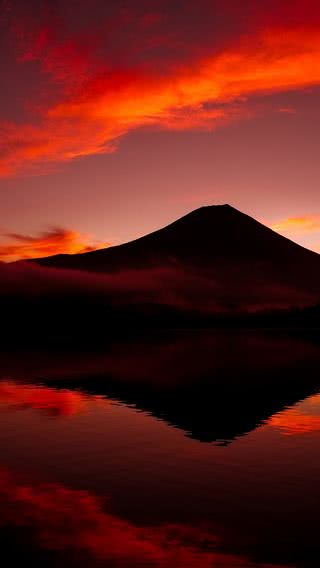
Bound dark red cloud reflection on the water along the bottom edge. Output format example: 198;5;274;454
0;468;288;568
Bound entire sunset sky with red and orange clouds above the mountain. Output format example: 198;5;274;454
0;0;320;260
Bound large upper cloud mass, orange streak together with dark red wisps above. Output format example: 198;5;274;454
0;2;320;175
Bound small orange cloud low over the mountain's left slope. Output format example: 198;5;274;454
0;227;110;262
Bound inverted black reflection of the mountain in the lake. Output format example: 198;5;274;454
1;331;320;443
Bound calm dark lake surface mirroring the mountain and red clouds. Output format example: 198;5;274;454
0;331;320;568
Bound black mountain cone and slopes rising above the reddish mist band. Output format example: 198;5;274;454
30;205;320;272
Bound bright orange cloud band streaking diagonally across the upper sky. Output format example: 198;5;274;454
0;25;320;176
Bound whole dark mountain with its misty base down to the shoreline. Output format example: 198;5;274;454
0;205;320;344
